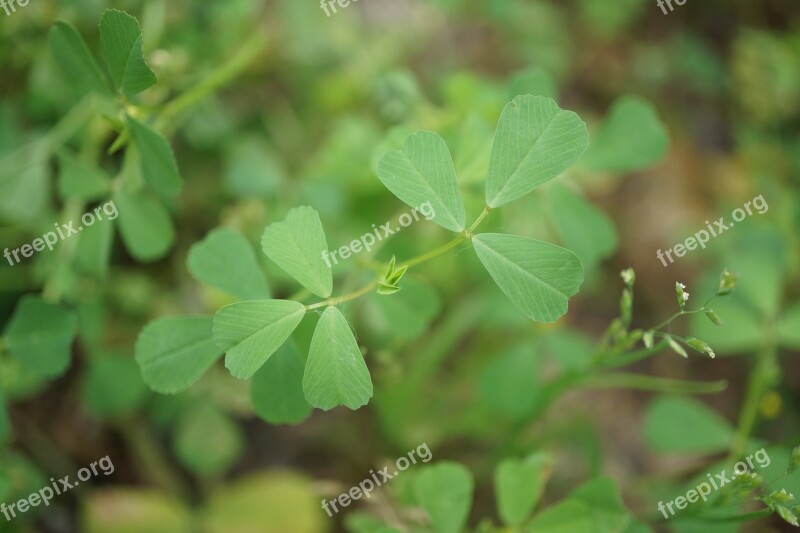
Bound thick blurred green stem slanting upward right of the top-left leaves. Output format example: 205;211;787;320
156;30;269;130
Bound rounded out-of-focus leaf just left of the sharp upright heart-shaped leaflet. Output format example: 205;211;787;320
187;228;271;300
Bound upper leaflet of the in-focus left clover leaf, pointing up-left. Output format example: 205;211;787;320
261;206;333;298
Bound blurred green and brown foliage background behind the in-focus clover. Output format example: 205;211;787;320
0;0;800;533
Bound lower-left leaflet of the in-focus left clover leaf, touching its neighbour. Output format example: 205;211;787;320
214;300;306;379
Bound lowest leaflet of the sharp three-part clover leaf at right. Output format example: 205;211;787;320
472;233;583;322
